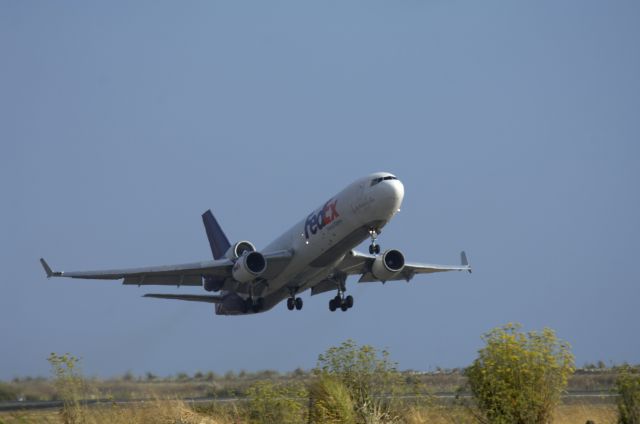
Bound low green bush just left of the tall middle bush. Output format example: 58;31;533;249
247;381;307;424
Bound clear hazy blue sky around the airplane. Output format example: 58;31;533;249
0;1;640;379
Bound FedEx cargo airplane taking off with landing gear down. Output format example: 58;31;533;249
40;172;471;315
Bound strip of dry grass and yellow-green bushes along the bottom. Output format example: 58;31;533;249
0;325;640;424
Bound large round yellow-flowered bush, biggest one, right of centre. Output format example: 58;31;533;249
465;324;574;424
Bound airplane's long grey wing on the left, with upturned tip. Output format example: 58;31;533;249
40;251;292;286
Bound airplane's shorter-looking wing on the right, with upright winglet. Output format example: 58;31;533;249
337;251;471;283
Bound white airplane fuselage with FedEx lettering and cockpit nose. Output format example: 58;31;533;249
216;172;404;314
